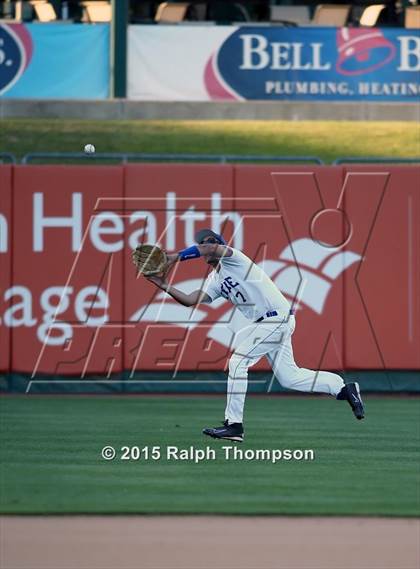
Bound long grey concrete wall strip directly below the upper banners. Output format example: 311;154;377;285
0;99;420;122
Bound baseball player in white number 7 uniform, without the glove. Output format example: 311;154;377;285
147;229;364;442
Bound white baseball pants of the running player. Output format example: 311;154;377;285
225;316;344;424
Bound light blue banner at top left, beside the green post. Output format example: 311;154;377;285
0;23;110;99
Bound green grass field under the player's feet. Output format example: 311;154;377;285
0;396;420;516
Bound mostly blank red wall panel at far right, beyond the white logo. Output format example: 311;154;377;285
343;165;420;369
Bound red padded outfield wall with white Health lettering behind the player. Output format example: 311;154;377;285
0;164;420;377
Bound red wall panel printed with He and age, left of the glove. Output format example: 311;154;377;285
12;166;124;378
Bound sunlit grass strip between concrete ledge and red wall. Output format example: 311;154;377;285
0;119;420;162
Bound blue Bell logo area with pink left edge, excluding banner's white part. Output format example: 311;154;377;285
204;27;420;101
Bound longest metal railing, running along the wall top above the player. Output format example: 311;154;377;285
21;152;324;165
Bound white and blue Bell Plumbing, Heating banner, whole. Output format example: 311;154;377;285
128;26;420;102
